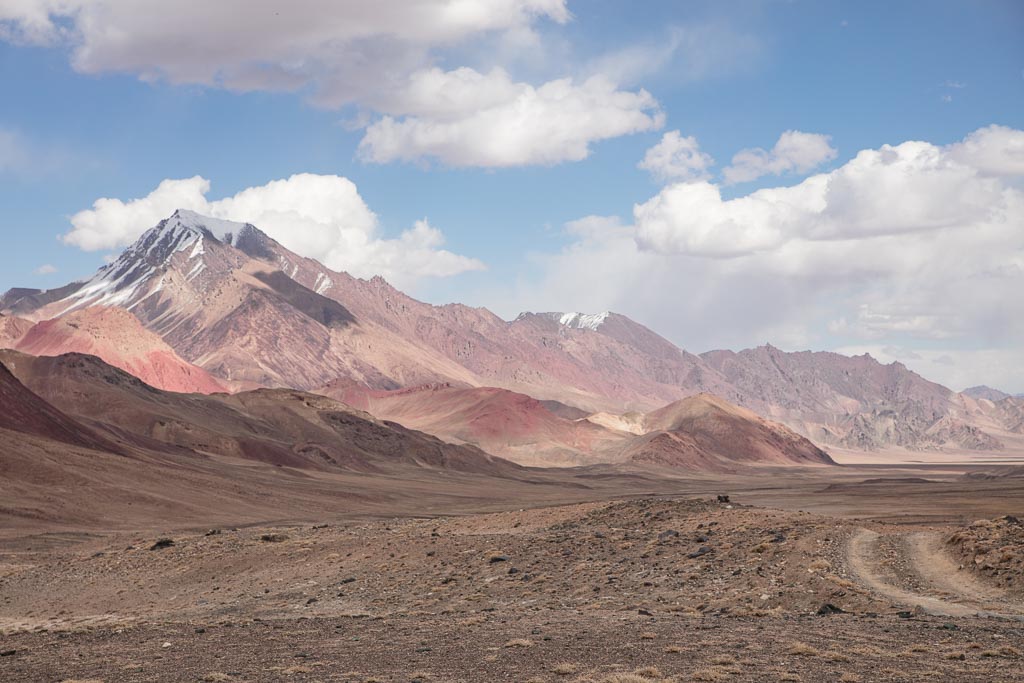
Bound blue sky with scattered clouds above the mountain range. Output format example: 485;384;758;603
0;0;1024;391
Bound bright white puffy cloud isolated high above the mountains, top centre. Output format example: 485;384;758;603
359;68;664;167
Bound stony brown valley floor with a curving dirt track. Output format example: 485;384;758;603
0;458;1024;683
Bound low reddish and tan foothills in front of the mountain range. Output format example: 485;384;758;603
323;385;831;472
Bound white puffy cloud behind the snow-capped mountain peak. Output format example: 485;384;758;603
63;173;484;287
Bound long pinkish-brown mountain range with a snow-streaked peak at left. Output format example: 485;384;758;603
0;210;1024;460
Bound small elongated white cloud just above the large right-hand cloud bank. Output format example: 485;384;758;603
722;130;838;183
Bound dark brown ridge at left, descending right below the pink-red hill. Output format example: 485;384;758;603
0;351;518;475
